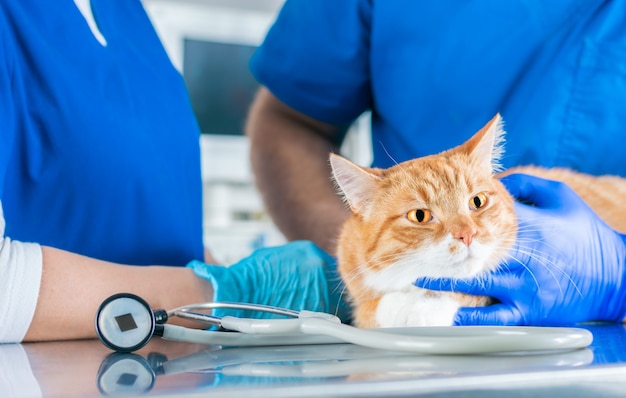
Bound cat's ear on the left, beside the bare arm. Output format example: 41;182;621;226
330;153;380;213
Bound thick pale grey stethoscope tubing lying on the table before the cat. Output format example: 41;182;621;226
162;316;593;355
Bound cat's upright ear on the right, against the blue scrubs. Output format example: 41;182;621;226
463;113;504;173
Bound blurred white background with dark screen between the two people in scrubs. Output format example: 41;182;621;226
143;0;371;264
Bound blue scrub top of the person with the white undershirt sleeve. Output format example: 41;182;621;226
0;0;203;265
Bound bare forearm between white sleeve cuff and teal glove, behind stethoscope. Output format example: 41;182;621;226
24;247;213;341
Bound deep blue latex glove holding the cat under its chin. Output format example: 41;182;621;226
415;174;626;326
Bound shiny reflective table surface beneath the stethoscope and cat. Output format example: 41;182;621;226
0;325;626;397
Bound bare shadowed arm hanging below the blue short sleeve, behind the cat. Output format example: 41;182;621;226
246;89;348;253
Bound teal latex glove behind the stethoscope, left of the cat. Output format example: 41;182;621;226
187;241;350;322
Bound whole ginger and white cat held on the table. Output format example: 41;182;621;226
330;115;626;327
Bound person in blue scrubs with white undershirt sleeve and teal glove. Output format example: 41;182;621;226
0;0;342;343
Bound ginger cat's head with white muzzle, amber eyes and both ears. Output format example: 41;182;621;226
331;116;517;292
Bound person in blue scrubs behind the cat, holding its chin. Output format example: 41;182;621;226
246;0;626;324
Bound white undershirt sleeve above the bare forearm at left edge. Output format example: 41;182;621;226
0;202;43;343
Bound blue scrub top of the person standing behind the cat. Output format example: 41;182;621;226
251;0;626;176
